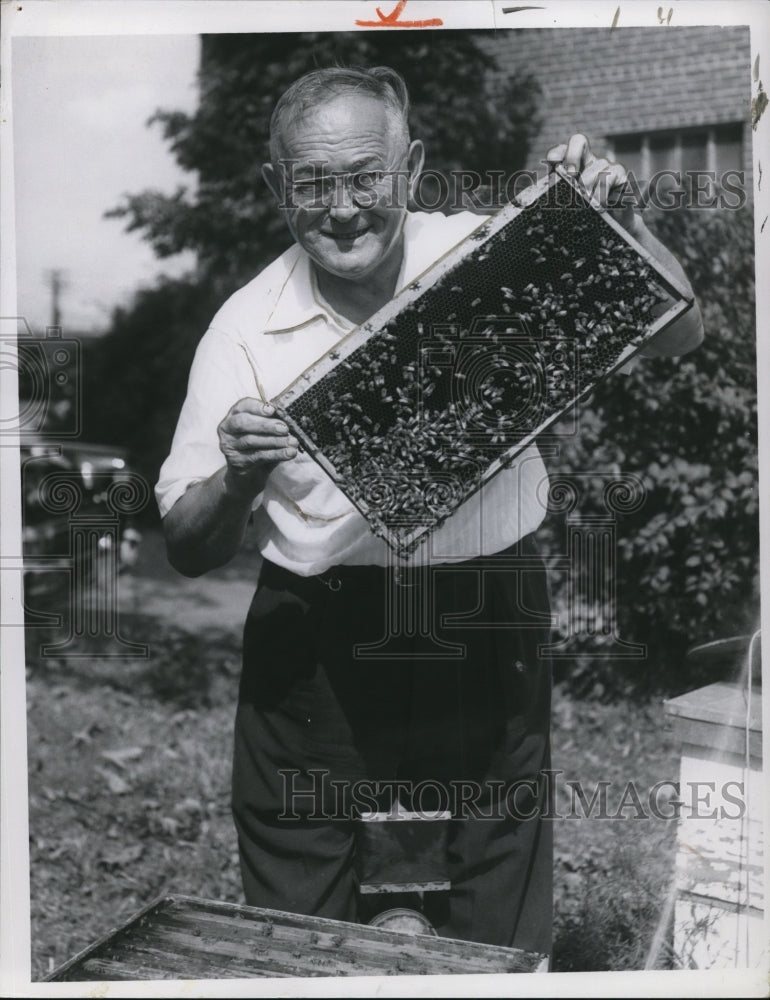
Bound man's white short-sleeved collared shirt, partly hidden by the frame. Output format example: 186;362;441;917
155;212;548;576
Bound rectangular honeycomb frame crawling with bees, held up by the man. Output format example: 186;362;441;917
273;168;693;557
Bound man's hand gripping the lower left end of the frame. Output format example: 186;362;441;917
217;398;298;497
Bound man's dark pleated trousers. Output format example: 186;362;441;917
233;539;552;952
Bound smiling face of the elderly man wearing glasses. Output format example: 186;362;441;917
266;93;422;282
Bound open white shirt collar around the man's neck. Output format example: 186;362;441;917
263;212;424;334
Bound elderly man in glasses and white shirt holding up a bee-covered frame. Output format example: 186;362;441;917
157;67;702;952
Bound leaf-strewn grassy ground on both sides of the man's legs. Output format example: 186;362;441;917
22;533;678;978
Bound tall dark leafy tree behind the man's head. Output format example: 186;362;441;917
109;31;538;293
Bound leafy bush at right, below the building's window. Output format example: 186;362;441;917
551;207;759;690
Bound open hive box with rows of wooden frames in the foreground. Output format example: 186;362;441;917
46;896;545;982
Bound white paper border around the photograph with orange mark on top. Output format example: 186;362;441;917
0;0;770;997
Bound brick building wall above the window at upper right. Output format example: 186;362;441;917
480;26;753;191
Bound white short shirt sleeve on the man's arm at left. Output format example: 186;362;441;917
155;327;259;517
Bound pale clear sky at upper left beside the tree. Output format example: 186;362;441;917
11;35;199;335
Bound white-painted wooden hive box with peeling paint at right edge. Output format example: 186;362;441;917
664;681;768;969
